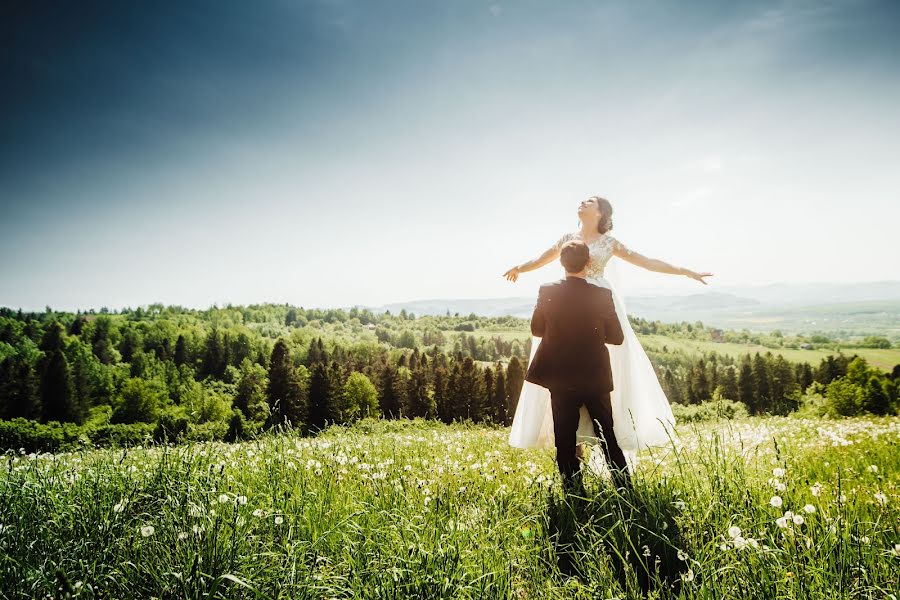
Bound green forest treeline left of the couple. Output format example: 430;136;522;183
0;305;524;449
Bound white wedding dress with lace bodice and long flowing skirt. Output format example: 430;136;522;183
509;232;677;472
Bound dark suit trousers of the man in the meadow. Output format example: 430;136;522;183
550;389;630;487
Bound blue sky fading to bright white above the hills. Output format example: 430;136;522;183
0;0;900;310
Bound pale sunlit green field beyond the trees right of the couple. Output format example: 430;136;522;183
639;335;900;371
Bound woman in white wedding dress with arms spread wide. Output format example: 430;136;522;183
503;196;712;470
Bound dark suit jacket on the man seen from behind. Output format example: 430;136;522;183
525;277;624;392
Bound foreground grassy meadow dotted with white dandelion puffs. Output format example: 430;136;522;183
0;417;900;599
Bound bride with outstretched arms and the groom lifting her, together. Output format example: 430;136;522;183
504;196;711;489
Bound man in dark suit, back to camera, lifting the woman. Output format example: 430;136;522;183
525;240;629;489
